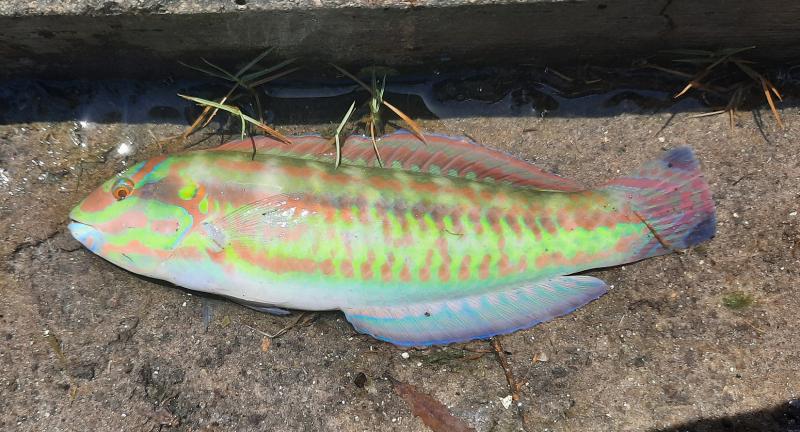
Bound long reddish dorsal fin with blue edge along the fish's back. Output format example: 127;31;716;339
214;131;585;192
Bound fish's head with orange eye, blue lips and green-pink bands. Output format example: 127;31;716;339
69;157;197;279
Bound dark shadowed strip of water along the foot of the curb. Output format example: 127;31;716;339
0;72;705;125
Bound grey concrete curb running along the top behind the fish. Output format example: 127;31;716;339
0;0;800;79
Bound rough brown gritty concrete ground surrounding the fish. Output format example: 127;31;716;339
0;76;800;432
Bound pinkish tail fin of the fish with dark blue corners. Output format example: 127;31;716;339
604;147;717;258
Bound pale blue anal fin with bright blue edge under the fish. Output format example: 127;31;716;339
344;276;608;346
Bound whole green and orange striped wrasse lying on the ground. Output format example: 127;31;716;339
69;132;716;346
